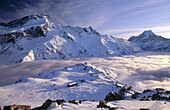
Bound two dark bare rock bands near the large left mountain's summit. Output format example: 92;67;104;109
0;14;54;44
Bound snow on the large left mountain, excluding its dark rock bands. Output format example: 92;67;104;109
0;16;141;63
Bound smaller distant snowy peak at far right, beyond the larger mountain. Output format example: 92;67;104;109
128;30;170;51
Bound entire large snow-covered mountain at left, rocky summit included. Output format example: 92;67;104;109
0;14;141;62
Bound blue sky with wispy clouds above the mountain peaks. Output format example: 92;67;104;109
0;0;170;39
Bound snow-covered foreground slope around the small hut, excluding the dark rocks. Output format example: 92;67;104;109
0;63;134;107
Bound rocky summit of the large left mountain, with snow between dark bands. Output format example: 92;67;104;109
0;13;54;44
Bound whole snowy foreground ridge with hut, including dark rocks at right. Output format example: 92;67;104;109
0;63;170;109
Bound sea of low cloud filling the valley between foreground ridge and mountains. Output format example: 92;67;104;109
0;52;170;92
